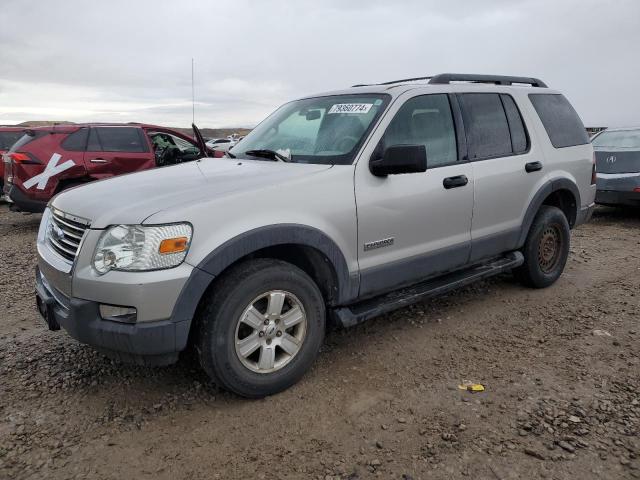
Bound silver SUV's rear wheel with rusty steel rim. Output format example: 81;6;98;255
513;205;571;288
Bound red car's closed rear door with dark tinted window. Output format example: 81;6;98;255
84;126;156;178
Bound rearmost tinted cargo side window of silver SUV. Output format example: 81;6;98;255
529;93;589;148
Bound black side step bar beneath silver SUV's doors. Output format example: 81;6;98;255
333;252;524;328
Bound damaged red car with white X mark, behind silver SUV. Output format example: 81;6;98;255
3;123;213;212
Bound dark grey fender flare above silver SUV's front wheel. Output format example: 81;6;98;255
171;224;359;332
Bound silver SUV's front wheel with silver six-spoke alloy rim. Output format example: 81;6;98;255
196;259;326;398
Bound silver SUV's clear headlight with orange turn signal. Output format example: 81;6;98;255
93;223;193;274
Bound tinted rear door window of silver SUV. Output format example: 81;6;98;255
459;93;513;160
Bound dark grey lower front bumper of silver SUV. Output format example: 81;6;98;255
36;269;191;365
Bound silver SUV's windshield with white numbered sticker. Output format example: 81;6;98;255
231;94;390;165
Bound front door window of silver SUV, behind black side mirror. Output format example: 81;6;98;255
384;94;458;167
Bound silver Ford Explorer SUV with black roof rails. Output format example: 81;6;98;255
37;74;595;397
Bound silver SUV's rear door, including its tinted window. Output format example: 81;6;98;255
458;93;544;262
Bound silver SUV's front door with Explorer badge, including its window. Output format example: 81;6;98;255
355;94;473;297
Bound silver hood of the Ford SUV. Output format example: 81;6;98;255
51;158;331;229
